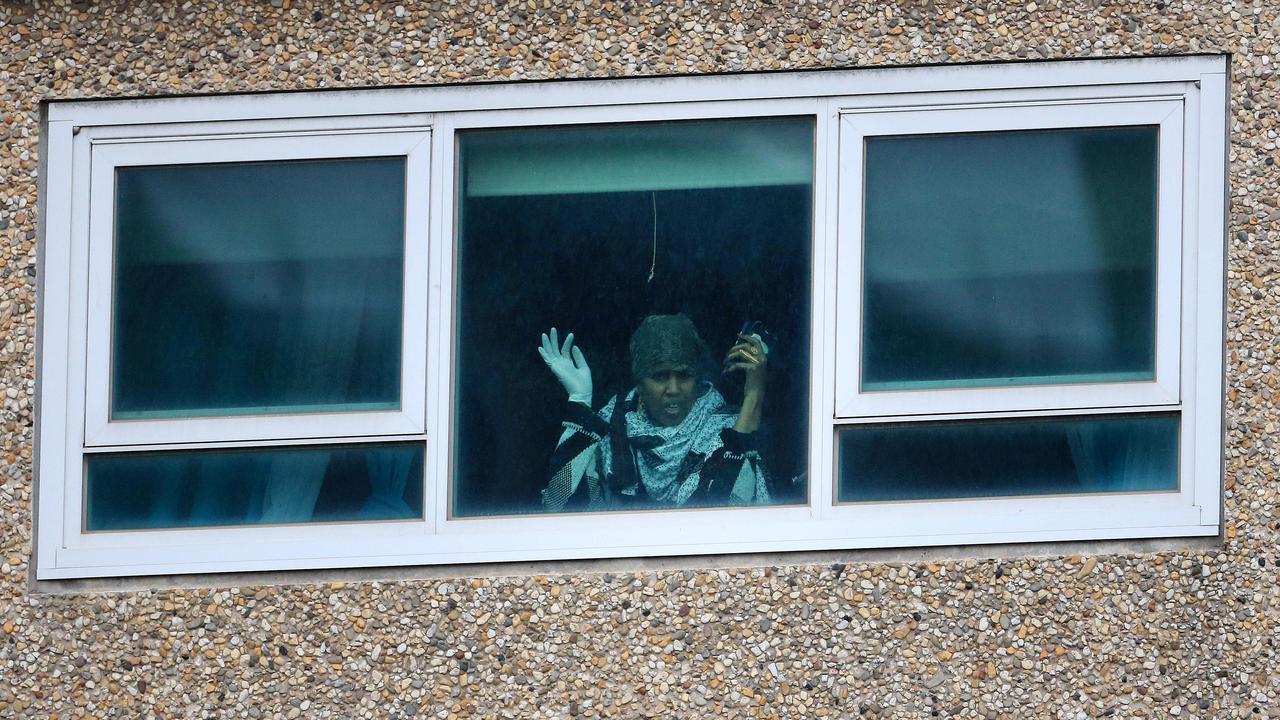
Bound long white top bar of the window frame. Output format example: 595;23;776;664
49;55;1226;127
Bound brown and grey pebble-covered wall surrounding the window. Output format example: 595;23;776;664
0;0;1280;719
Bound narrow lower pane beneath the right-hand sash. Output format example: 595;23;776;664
838;413;1179;502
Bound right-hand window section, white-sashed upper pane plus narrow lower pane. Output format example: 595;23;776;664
837;99;1183;502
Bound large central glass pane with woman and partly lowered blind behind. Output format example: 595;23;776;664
451;118;814;515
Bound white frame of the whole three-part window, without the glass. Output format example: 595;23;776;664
36;56;1228;579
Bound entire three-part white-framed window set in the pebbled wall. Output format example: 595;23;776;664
37;56;1226;578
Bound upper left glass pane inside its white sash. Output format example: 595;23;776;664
111;158;404;420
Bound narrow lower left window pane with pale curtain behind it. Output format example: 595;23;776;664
84;445;422;532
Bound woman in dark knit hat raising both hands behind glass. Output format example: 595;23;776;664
538;314;769;512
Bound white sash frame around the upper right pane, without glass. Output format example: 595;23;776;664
835;96;1194;419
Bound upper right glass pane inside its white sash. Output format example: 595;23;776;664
861;127;1157;391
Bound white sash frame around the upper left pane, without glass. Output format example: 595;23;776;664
84;128;430;447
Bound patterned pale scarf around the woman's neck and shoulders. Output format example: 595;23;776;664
600;383;737;505
